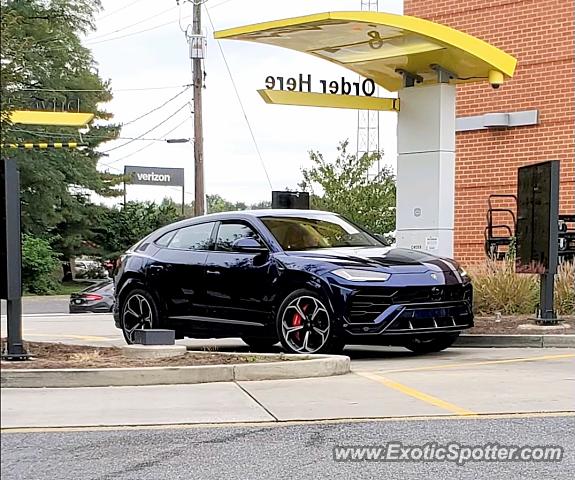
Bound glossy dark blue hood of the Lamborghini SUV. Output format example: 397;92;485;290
286;247;457;273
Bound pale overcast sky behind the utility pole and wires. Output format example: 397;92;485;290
90;0;403;203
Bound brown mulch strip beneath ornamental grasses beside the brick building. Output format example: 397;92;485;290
470;315;575;335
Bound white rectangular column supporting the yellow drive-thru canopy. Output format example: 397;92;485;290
396;83;455;257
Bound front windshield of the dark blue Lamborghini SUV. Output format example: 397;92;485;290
261;215;381;250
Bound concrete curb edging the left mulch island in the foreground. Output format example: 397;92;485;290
0;352;350;388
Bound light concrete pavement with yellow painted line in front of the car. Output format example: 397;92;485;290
1;348;575;428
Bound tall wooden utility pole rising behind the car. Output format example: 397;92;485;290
188;0;206;216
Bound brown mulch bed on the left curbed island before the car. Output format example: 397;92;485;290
1;341;287;369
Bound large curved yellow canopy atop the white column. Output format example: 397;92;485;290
214;12;517;91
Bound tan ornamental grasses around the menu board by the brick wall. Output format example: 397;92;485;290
469;258;575;315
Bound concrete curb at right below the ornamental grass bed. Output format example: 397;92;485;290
453;335;575;348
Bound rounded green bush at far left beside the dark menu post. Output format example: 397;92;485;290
22;235;60;295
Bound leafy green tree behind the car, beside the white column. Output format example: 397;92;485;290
299;141;395;234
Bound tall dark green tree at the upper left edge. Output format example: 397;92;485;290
0;0;122;256
